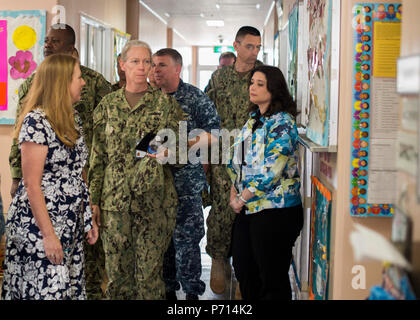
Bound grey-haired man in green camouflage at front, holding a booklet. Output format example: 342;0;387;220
88;40;184;300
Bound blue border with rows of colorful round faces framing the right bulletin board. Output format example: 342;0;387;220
350;3;402;217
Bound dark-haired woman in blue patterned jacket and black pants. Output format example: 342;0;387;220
228;66;303;300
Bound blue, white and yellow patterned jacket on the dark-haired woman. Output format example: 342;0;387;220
228;110;301;214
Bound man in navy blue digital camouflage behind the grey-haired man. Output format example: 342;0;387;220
152;48;220;300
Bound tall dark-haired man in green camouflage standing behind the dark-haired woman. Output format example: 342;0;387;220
206;26;262;294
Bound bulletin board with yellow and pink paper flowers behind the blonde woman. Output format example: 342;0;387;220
0;10;46;125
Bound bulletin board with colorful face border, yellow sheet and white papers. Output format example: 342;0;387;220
350;3;402;217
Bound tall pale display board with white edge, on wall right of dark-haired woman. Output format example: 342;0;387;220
304;0;340;147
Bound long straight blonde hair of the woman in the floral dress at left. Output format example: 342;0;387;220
14;54;79;147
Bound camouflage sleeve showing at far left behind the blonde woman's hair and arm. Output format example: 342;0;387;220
9;77;32;179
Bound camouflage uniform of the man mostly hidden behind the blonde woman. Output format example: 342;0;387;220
9;66;111;299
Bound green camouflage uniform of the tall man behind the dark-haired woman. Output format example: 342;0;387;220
205;61;262;259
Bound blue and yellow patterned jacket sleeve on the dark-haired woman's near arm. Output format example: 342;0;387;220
245;121;297;197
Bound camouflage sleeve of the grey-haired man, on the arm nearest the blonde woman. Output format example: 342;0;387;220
88;99;108;205
